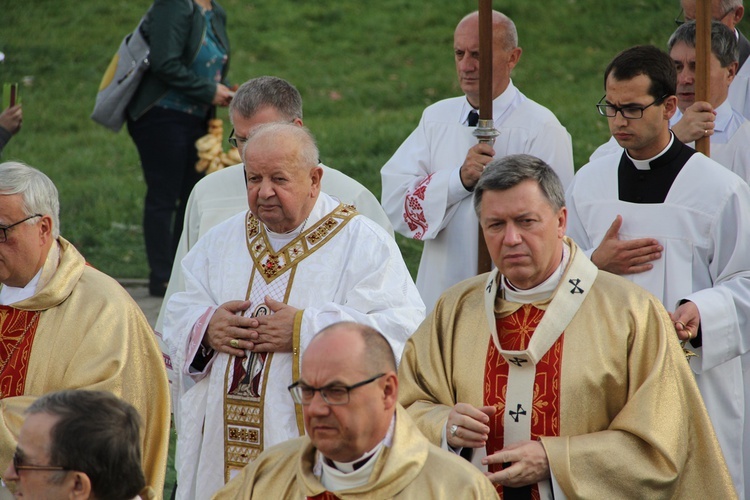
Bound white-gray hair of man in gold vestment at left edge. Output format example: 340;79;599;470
0;161;60;238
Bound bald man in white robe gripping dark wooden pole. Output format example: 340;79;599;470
381;11;573;310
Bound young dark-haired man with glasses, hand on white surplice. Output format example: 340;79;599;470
566;46;750;497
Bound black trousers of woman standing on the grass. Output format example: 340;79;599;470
128;107;208;288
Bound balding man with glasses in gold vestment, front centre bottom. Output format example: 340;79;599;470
214;323;497;500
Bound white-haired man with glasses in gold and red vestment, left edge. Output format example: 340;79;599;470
0;162;170;490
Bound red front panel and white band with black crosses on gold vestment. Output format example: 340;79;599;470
484;237;598;498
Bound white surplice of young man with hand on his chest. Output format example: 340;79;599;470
566;153;750;498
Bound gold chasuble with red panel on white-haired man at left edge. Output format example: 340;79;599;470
0;237;170;492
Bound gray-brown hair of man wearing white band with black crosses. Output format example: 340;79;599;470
474;155;565;217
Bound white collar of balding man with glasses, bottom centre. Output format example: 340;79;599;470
313;414;396;491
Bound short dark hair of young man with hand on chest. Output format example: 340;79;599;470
604;45;677;99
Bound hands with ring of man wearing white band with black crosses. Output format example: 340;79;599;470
445;403;550;488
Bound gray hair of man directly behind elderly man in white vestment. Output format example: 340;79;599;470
229;76;302;122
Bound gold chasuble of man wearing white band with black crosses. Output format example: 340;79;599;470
399;239;735;498
